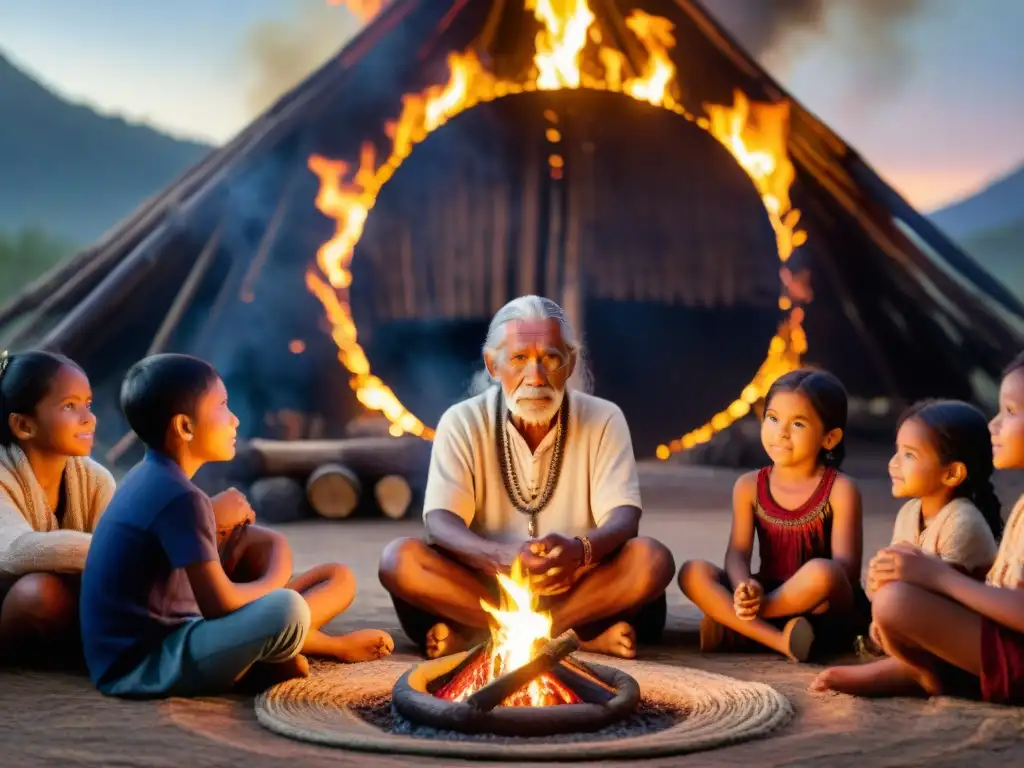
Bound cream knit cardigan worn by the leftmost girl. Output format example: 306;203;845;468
0;445;115;577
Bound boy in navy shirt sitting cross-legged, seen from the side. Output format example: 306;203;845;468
80;354;310;696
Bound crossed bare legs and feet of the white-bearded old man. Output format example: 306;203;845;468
380;538;675;658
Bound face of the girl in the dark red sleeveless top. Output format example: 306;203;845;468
761;392;831;467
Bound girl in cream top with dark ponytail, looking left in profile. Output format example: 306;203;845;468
811;400;1002;695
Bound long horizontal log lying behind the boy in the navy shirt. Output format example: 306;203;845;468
247;435;430;487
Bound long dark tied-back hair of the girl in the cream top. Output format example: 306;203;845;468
897;400;1002;541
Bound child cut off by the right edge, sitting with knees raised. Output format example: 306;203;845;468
806;354;1024;706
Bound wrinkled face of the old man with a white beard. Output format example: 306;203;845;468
484;319;575;425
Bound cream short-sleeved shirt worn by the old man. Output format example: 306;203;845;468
423;386;641;542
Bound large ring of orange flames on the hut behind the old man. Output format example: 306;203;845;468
306;0;809;459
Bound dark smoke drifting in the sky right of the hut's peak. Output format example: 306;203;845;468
705;0;924;98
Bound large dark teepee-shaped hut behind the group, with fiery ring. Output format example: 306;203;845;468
0;0;1024;460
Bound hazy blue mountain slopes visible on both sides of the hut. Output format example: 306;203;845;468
0;49;1024;300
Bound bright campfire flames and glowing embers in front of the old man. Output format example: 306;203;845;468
434;560;581;707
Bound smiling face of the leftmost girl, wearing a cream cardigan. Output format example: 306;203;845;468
11;366;96;456
